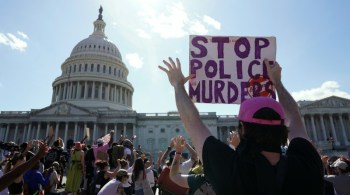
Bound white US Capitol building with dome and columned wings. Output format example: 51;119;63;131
0;8;350;157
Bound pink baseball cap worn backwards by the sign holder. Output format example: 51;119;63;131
238;97;286;125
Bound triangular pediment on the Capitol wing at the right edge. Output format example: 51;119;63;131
302;96;350;108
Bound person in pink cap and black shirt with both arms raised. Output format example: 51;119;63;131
159;58;324;194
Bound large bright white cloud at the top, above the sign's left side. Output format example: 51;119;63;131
138;2;221;39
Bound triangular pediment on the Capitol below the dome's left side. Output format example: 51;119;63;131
32;102;92;116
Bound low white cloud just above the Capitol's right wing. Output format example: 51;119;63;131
292;81;350;101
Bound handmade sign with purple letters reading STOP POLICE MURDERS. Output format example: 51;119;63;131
189;35;276;104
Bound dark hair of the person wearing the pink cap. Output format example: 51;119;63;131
239;107;288;148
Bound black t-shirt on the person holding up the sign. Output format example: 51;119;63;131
202;136;324;195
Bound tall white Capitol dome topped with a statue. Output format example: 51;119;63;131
51;7;134;111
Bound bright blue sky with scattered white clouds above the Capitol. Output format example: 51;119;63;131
0;0;350;115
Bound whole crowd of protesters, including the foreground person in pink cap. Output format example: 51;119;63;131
0;58;350;195
